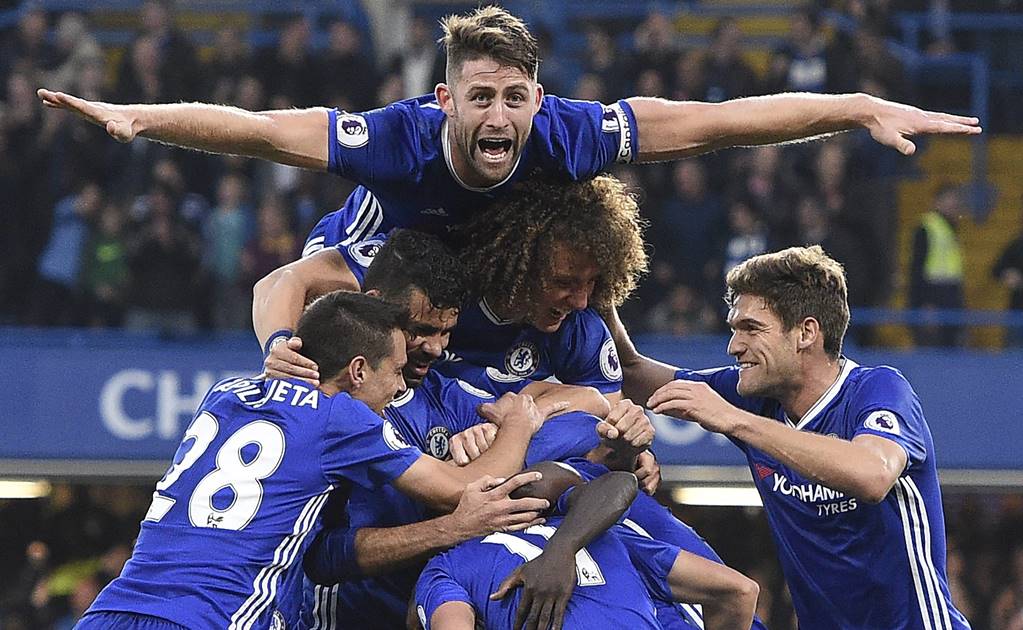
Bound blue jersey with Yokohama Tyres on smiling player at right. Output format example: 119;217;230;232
676;359;970;630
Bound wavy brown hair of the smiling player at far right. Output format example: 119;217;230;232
724;245;849;357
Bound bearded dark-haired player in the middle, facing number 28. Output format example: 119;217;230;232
296;230;653;628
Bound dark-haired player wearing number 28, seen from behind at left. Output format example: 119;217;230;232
79;291;546;629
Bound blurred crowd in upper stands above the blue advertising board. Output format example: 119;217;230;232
0;0;941;341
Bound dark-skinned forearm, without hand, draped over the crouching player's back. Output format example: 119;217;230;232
544;471;637;556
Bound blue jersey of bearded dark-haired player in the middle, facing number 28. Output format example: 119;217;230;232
303;370;598;630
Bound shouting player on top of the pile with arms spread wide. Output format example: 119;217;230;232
38;6;980;242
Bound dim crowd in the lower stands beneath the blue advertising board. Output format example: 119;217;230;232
0;485;1023;630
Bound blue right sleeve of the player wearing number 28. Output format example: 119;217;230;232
321;394;424;490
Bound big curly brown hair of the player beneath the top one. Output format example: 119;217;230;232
461;175;647;312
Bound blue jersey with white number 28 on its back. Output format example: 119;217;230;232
79;378;421;630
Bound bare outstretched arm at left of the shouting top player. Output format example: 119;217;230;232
37;89;328;171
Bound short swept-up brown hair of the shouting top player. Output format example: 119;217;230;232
439;6;540;84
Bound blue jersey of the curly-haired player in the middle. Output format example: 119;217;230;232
436;300;622;394
